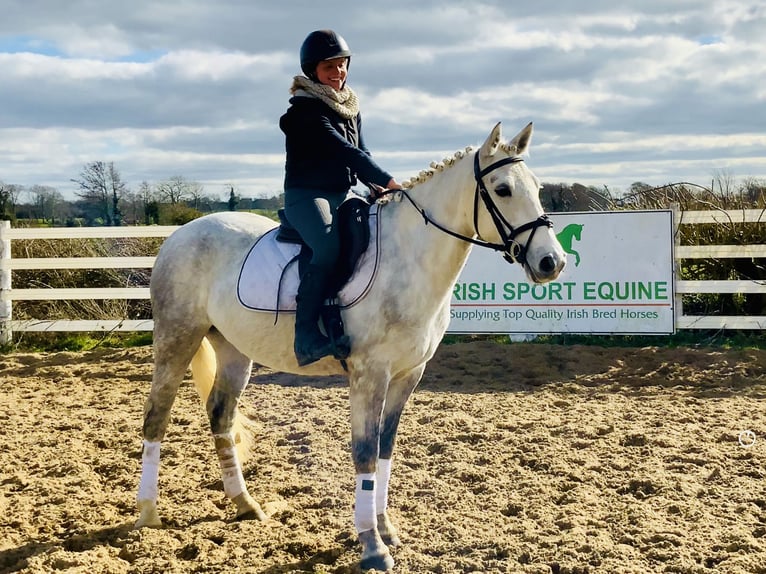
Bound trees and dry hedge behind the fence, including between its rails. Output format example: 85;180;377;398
6;176;766;328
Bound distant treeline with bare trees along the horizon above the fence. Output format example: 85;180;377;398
0;161;766;226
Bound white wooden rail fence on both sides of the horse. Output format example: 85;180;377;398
0;209;766;343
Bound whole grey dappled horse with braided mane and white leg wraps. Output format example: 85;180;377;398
136;124;565;570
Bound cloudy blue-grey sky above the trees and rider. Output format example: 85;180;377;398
0;0;766;199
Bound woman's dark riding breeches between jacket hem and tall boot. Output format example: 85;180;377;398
285;188;346;272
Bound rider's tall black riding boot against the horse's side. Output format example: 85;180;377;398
295;265;335;367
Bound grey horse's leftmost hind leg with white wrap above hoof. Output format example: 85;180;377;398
135;321;207;528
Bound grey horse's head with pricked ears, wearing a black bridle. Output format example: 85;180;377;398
474;122;566;283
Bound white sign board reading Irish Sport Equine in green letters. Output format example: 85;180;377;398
447;211;675;334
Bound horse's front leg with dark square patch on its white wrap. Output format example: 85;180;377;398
349;365;394;571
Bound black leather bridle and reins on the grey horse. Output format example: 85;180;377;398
396;152;553;266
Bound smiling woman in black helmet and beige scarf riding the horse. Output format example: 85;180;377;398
279;30;401;366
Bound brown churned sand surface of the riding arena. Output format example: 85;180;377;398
0;342;766;574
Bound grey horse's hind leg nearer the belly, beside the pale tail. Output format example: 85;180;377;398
201;331;266;520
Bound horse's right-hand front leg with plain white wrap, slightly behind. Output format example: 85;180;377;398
375;364;425;547
